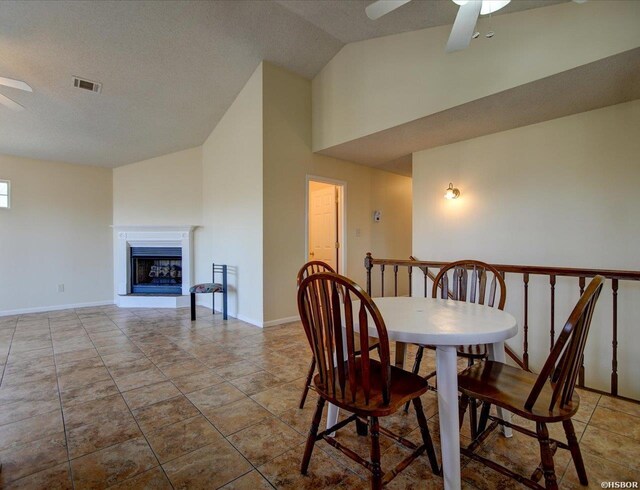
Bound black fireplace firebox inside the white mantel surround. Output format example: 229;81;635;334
130;247;182;294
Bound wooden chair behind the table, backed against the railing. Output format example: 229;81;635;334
405;260;507;436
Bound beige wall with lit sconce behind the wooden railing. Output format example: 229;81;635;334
413;101;640;397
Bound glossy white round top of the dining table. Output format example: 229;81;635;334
362;296;518;345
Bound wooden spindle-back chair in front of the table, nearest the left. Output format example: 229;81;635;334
298;272;439;489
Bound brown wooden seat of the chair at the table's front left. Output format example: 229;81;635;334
313;357;429;417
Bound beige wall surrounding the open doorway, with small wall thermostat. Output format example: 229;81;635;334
264;63;411;325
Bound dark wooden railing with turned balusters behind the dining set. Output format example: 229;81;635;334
364;253;640;401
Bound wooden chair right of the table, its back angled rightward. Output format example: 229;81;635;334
458;276;605;489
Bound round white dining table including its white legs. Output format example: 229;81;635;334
327;296;518;489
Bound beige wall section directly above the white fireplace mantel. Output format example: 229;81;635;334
113;146;202;226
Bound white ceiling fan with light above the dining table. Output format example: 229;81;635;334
365;0;587;52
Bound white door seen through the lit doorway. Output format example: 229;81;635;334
309;182;338;271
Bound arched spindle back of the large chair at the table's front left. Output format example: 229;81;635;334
298;272;391;405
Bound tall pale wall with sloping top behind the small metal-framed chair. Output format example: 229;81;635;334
195;65;263;325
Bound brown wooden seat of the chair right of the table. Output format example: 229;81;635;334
458;361;580;423
